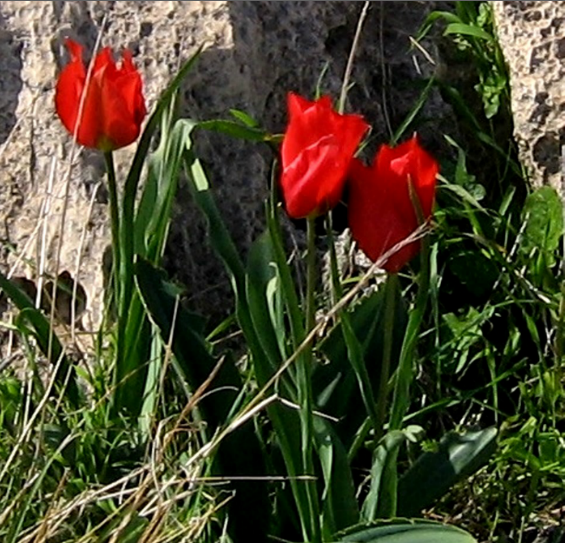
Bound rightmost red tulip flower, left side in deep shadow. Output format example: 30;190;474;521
348;136;439;273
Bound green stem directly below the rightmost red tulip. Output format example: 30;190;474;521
375;273;398;443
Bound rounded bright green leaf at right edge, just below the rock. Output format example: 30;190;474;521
520;186;563;254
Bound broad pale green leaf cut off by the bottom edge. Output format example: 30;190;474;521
336;519;477;543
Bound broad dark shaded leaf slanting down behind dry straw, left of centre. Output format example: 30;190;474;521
135;259;269;540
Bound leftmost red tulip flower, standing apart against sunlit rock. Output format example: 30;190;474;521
55;39;147;151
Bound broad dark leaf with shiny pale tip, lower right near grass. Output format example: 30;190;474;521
398;428;497;516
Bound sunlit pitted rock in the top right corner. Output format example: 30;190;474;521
492;1;565;193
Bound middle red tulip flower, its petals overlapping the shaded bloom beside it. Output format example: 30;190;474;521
280;93;369;219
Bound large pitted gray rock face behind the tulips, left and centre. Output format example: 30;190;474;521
0;1;449;328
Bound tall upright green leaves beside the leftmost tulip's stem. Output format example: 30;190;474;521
109;50;200;423
